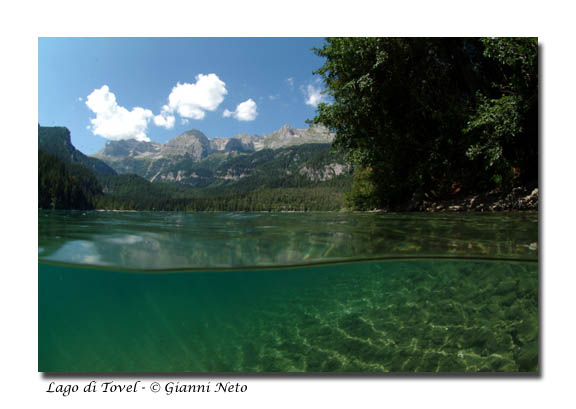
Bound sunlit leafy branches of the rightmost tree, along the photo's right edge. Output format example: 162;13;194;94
464;38;538;187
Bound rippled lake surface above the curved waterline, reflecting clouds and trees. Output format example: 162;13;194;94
38;211;538;270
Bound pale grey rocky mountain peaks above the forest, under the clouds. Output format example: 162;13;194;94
93;125;349;187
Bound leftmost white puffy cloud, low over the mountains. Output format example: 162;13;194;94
86;85;154;141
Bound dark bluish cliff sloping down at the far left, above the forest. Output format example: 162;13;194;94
38;125;116;175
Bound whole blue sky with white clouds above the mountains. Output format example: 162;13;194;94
38;38;325;154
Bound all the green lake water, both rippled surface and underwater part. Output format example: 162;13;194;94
38;212;539;372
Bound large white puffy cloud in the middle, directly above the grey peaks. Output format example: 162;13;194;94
167;74;228;119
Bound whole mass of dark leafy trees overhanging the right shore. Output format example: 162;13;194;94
312;38;538;208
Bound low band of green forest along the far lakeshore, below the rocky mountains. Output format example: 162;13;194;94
38;147;350;211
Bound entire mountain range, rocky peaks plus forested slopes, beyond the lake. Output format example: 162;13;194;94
38;125;352;211
